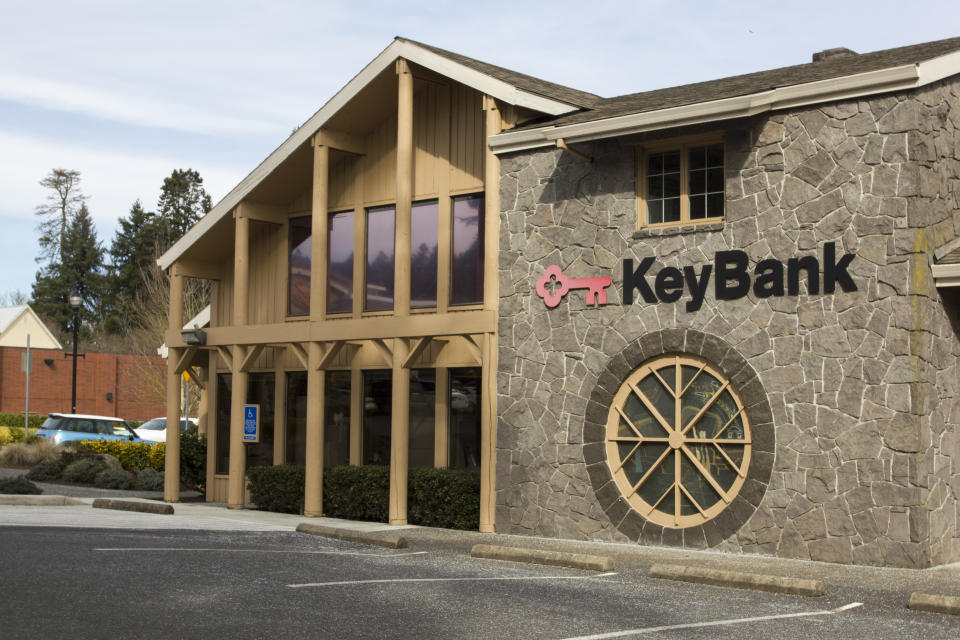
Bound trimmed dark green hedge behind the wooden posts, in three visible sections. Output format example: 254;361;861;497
247;465;480;530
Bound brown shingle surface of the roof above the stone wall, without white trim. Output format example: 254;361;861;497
521;38;960;128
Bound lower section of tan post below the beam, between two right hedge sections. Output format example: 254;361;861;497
390;338;410;525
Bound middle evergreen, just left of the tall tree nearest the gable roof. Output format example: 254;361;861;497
103;200;158;334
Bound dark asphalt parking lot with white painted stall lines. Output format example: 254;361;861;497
0;507;960;639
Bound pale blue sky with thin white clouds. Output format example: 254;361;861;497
0;0;960;305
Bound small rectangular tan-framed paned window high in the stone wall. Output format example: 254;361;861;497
637;133;726;229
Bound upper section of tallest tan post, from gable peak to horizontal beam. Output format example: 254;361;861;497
393;58;413;316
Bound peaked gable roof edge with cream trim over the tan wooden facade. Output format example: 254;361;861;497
157;37;601;269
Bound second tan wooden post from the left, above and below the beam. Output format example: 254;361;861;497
227;210;250;509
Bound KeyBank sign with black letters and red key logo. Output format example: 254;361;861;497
536;242;857;312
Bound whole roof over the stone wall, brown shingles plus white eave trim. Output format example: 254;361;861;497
490;38;960;153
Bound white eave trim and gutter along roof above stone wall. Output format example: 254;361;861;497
490;61;936;154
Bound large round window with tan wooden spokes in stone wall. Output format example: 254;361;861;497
606;355;750;528
